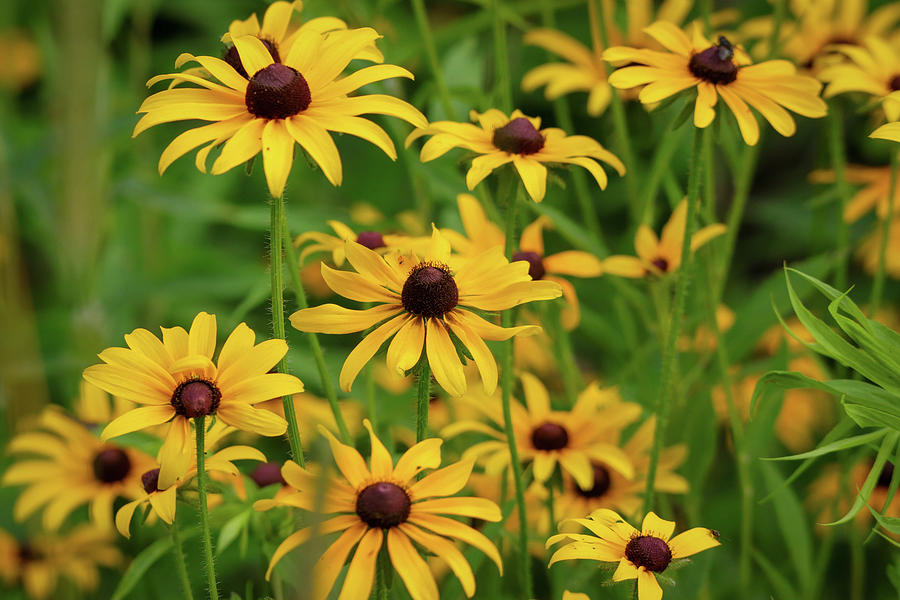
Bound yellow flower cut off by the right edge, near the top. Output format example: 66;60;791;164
819;37;900;121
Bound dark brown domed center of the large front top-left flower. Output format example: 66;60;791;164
244;63;312;119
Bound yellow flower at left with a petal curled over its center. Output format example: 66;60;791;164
84;312;303;489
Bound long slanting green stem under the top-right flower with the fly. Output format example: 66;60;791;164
644;129;706;514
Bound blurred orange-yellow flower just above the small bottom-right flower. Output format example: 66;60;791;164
556;414;688;518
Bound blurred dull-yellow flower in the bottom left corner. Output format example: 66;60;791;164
0;525;123;600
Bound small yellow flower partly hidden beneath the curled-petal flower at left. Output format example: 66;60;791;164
116;440;266;537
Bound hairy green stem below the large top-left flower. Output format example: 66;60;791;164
269;196;304;466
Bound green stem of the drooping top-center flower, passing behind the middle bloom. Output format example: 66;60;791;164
500;180;532;598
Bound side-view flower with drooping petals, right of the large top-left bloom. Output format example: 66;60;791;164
406;108;625;202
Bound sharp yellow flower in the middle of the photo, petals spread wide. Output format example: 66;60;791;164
291;229;562;396
